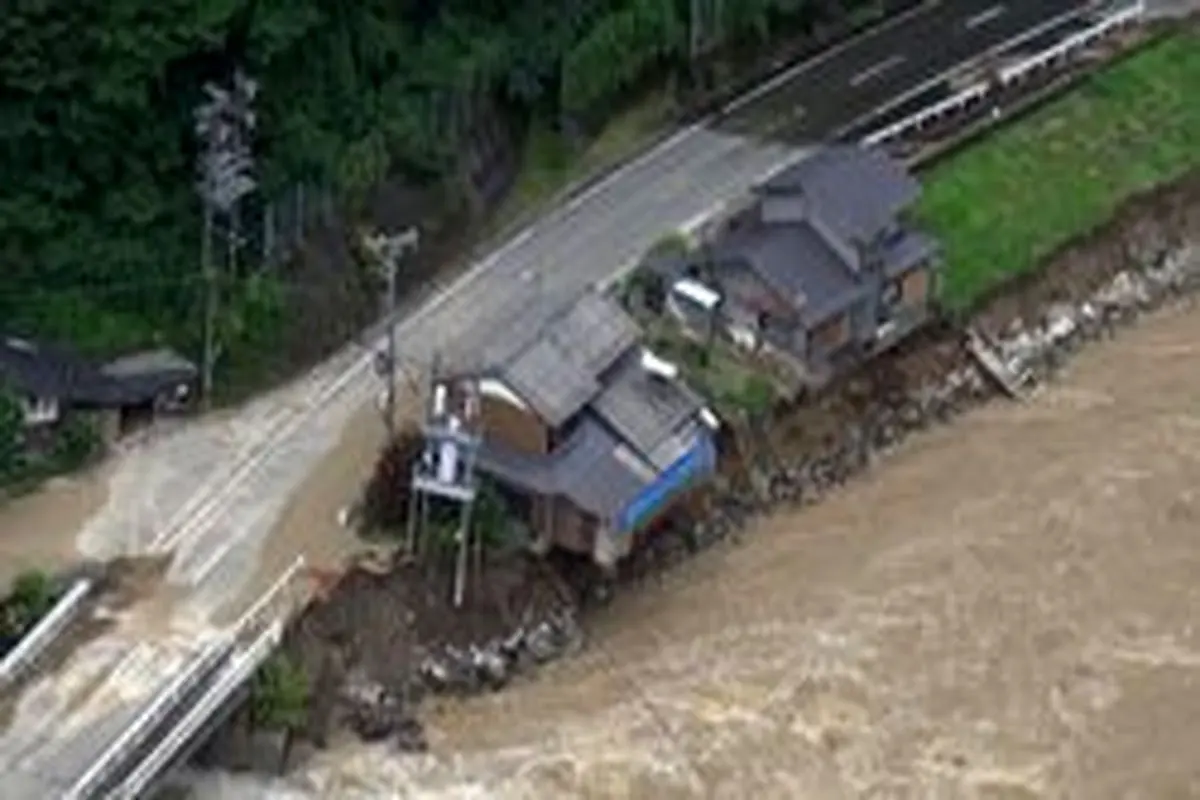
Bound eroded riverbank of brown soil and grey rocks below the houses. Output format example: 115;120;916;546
194;174;1200;782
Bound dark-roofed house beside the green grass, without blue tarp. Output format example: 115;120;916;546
667;145;940;387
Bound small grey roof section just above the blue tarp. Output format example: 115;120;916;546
592;349;703;470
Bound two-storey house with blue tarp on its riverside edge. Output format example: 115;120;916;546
420;293;718;566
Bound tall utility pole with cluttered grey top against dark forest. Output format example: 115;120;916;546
194;70;258;405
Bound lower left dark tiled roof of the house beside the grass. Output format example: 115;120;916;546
715;222;858;324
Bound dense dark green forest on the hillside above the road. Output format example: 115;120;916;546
0;0;878;393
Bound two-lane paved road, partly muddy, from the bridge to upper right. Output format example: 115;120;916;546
0;0;1078;800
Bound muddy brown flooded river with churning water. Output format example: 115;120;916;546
187;303;1200;800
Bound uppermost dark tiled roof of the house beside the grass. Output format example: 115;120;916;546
760;145;920;243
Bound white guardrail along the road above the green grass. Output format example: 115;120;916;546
862;0;1146;146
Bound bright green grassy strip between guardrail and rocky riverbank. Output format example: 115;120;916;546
917;30;1200;311
